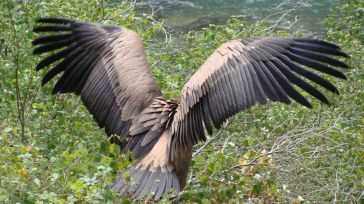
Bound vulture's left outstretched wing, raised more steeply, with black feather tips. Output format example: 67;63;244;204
33;18;161;150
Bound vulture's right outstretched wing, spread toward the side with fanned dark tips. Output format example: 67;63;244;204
172;38;348;146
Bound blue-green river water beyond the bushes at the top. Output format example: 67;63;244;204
138;0;340;33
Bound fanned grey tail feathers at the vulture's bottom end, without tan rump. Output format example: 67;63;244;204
112;166;180;201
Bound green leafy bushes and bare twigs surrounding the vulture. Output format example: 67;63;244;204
0;0;364;203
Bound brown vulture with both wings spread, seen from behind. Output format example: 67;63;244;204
33;18;349;200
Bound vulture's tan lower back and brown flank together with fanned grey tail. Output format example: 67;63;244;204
113;130;192;201
